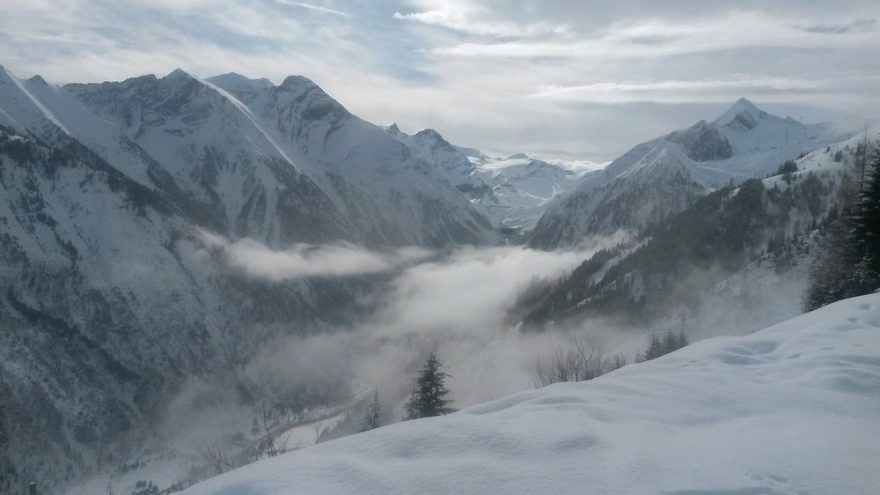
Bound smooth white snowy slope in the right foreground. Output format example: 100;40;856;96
184;295;880;495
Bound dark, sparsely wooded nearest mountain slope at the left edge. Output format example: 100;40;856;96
0;122;384;490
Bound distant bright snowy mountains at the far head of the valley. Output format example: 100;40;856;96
386;124;583;232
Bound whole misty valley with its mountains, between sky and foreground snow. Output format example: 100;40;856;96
0;64;880;495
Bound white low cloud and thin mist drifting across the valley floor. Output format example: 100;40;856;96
163;234;803;462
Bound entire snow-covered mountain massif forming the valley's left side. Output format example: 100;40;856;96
0;68;494;491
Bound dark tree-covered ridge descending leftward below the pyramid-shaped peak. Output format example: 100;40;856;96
518;165;834;328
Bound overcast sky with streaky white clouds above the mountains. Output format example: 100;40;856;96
0;0;880;161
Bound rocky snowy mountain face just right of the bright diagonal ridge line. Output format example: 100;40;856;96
208;74;493;246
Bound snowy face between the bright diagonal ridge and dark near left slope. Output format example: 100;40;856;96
0;63;354;245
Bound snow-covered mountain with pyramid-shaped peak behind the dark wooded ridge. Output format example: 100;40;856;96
528;98;842;248
